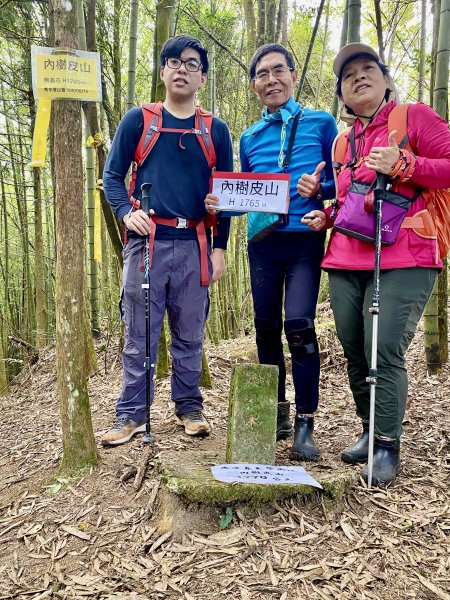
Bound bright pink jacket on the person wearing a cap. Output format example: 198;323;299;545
322;102;450;270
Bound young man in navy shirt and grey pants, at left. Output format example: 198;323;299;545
102;35;233;446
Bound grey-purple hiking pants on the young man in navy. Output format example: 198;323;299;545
116;237;211;421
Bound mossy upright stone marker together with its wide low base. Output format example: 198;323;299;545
155;365;355;505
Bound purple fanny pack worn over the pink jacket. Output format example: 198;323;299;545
333;181;414;246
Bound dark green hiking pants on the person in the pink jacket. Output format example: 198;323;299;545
328;267;437;438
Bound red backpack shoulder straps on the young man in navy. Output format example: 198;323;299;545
128;102;216;200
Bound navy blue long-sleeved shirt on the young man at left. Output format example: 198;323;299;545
103;107;233;248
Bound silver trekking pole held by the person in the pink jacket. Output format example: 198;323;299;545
366;173;386;490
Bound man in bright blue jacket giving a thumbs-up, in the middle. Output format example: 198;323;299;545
240;44;337;460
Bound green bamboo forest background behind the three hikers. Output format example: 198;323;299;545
0;0;450;394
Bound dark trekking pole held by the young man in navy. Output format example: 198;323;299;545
141;183;155;445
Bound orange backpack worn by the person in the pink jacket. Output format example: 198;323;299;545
332;104;450;262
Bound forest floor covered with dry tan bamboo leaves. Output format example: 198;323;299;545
0;306;450;600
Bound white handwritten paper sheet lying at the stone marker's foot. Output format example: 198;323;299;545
211;464;322;489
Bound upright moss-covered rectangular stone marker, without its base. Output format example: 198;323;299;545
225;365;278;465
